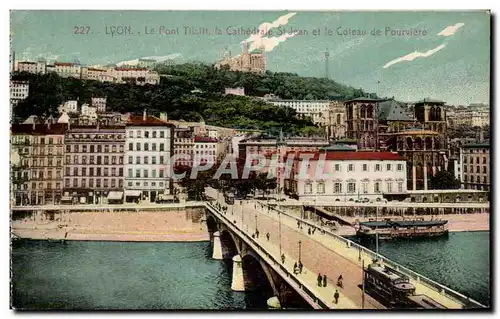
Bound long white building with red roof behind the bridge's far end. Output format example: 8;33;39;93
285;150;407;202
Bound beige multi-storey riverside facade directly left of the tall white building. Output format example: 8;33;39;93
64;126;125;204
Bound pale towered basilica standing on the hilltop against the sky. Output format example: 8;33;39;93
215;42;266;73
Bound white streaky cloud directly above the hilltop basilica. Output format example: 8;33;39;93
241;12;297;52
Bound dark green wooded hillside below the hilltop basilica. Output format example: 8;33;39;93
12;63;372;135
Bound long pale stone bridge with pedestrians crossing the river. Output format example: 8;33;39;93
202;189;484;309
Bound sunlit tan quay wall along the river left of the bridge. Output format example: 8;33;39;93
11;208;210;242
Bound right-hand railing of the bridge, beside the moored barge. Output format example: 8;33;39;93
260;203;486;308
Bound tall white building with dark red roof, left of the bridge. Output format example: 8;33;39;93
125;112;174;202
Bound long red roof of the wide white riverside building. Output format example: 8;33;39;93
287;151;406;161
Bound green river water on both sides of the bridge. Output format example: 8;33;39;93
12;232;489;309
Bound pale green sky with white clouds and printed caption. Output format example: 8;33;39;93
10;11;490;105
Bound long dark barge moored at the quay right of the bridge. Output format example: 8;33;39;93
356;218;448;240
